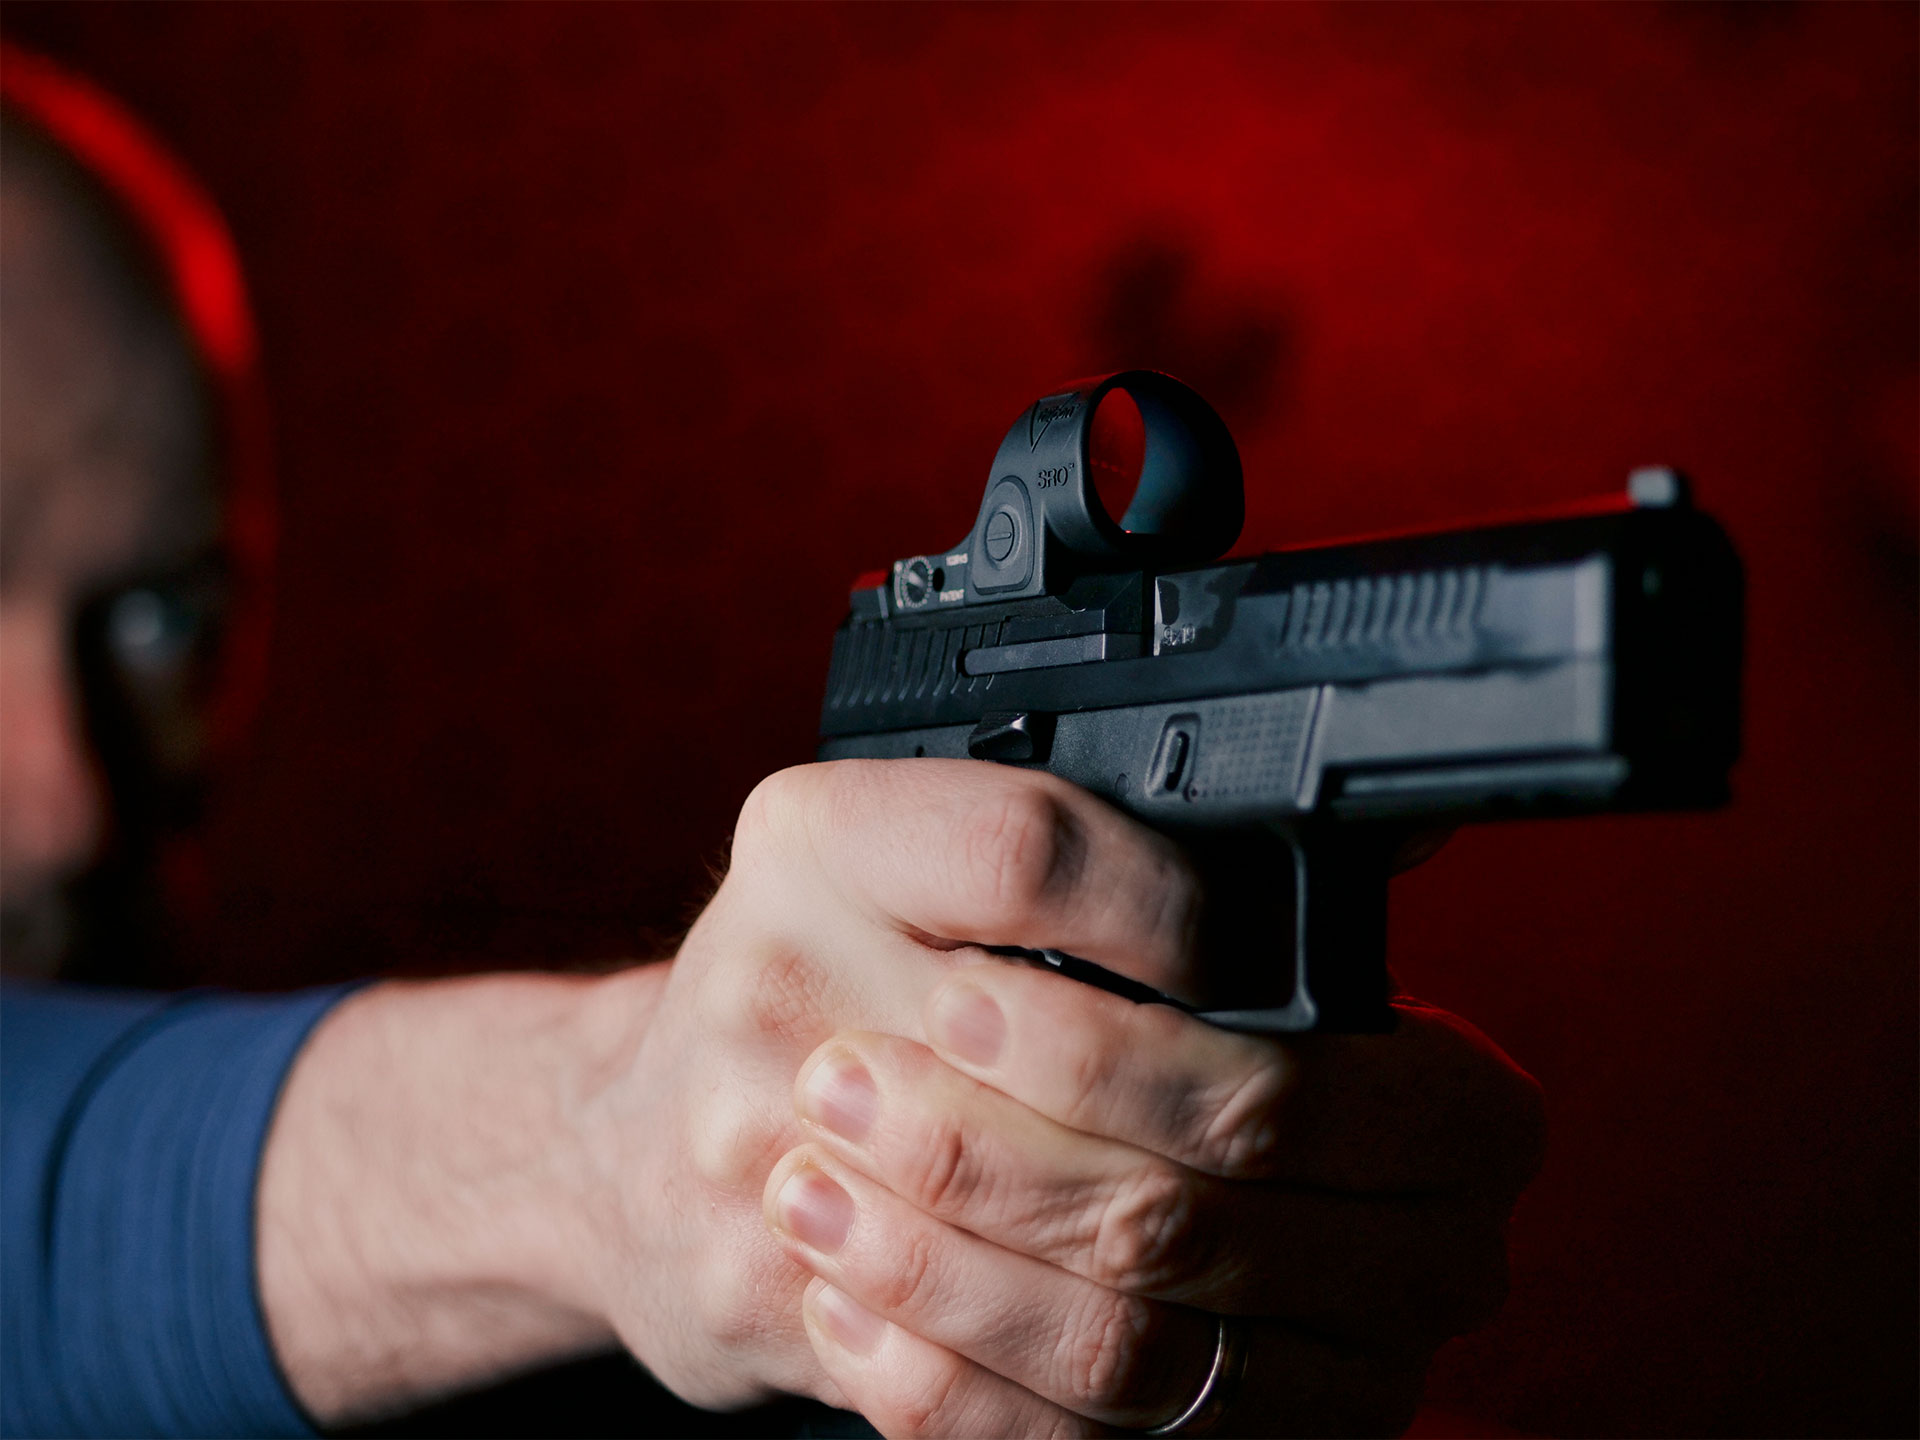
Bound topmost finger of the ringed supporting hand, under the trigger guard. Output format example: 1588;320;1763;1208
925;964;1544;1204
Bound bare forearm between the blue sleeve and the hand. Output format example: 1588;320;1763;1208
257;966;666;1425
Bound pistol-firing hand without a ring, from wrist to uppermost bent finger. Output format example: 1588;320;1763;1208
579;760;1200;1405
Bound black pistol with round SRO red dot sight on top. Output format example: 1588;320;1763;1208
818;371;1743;1033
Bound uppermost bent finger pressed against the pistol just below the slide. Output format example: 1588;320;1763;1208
733;758;1200;993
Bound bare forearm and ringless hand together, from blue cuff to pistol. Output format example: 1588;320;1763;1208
259;760;1200;1423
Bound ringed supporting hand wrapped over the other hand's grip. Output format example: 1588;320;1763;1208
766;948;1542;1434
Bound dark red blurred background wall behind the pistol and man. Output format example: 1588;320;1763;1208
6;0;1920;1434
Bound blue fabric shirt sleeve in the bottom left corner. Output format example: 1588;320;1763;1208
0;985;346;1436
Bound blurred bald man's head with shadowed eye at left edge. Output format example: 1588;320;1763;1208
0;98;223;972
